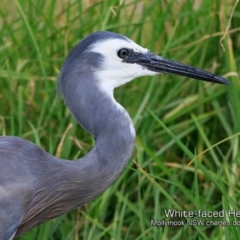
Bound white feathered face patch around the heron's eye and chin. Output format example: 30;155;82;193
90;38;157;97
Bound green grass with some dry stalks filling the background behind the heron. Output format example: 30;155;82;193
0;0;240;240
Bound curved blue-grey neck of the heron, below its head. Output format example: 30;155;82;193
57;73;135;204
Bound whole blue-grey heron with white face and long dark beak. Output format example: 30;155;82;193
0;32;229;240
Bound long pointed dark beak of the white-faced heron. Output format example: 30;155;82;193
123;49;231;85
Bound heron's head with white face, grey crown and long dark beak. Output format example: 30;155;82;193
58;31;230;98
